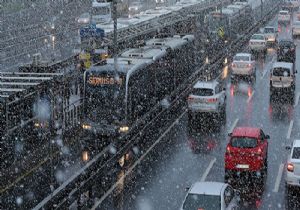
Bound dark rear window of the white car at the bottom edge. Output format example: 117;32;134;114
183;194;221;210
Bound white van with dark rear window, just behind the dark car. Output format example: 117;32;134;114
270;62;297;94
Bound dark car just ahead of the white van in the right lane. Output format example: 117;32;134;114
277;40;296;63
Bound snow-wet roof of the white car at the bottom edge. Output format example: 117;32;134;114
189;182;227;195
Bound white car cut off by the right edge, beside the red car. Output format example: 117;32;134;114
285;139;300;187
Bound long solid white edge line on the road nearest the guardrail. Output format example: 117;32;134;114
91;111;186;210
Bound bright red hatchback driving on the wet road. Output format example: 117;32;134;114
225;127;270;181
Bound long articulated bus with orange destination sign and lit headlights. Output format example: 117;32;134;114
82;36;195;137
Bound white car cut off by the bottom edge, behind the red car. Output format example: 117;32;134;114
180;182;240;210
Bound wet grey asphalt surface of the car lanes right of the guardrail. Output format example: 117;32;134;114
98;14;300;210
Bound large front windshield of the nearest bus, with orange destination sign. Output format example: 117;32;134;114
85;72;125;122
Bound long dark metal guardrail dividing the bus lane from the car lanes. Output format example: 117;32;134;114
36;0;279;209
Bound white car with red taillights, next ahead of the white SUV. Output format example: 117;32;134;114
231;53;256;80
